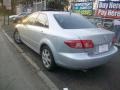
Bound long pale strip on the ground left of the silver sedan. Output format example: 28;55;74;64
3;30;59;90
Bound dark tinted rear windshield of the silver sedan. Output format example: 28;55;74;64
54;14;96;29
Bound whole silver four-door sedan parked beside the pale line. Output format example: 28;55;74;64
14;11;118;70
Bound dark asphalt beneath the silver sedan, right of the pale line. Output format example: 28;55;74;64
3;21;120;90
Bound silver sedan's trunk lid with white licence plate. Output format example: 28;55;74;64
63;28;114;55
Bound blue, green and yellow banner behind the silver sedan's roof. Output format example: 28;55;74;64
73;1;93;16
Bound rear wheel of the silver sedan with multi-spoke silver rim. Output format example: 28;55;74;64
41;46;56;71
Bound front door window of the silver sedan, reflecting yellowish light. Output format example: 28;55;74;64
23;13;38;25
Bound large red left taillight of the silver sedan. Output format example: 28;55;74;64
64;40;94;48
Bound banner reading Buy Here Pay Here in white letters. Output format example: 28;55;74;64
95;1;120;19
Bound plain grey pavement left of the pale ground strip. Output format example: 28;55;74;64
0;18;50;90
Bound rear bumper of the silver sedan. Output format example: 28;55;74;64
55;46;118;69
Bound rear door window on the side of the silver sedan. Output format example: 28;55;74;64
35;14;49;28
